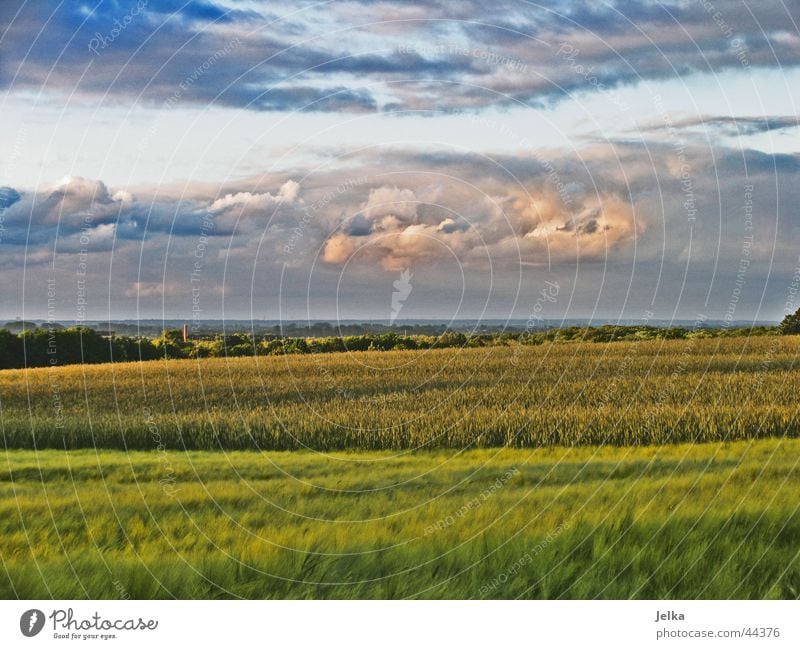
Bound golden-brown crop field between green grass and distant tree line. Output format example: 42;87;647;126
0;336;800;451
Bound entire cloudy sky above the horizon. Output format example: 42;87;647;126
0;0;800;324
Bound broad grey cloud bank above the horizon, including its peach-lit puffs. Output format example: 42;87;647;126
0;138;800;317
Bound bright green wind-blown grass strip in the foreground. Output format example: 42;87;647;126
0;439;800;599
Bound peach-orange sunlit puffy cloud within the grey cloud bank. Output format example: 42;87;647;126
323;171;646;270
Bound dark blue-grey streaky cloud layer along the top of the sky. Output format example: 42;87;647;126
0;0;800;112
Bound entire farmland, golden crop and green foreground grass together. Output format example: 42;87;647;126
0;336;800;599
